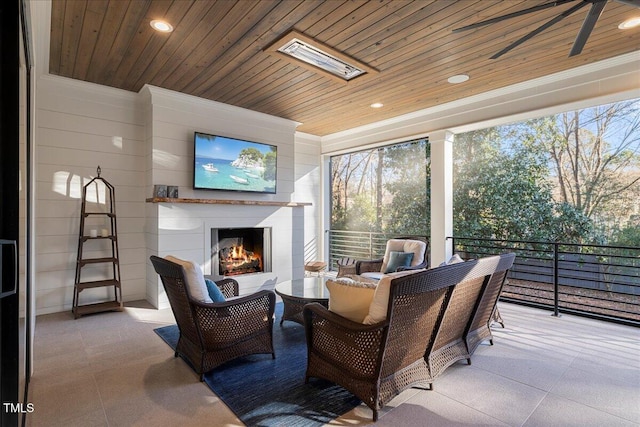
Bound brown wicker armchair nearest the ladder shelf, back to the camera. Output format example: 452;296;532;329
151;256;275;381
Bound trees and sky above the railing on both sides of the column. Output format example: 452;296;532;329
331;100;640;247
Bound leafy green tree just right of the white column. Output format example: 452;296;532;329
454;126;594;242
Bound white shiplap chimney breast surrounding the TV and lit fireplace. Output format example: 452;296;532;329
140;86;318;308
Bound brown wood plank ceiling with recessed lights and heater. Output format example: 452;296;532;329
49;0;640;135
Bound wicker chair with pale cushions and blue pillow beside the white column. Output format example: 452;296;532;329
355;237;429;280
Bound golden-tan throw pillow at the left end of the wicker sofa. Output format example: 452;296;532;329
326;278;376;323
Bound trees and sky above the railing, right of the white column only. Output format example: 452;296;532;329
454;101;640;246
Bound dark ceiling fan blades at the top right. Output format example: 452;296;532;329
453;0;640;59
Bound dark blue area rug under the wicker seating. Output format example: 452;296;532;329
155;303;360;426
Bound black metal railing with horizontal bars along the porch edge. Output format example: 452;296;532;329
327;230;640;326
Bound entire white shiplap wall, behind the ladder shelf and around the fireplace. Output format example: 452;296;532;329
35;76;323;314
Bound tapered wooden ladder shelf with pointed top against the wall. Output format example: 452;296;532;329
72;166;123;319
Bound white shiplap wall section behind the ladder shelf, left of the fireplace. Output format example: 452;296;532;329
35;76;146;314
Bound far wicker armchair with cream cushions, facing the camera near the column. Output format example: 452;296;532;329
355;237;429;279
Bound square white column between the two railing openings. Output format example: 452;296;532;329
429;130;454;267
